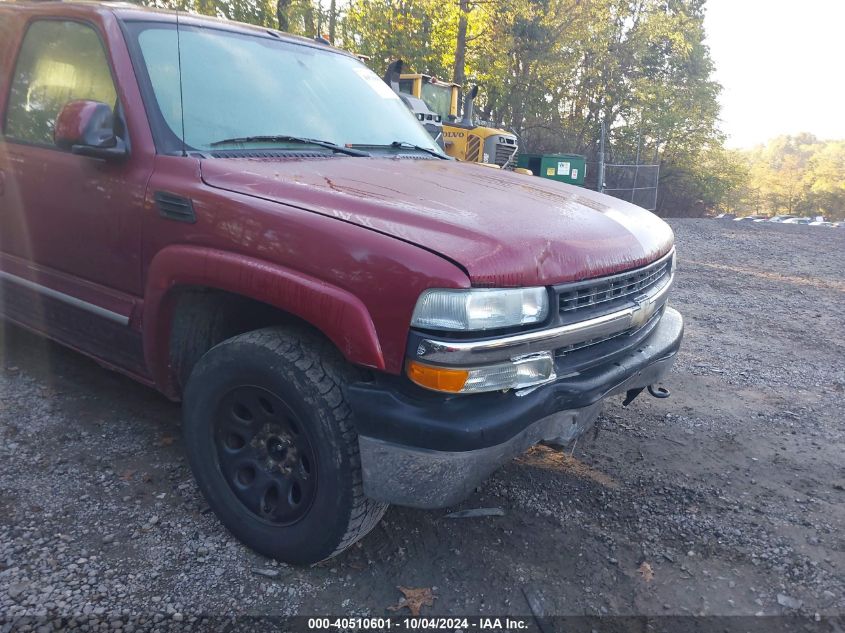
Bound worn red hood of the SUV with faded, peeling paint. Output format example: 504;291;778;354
202;157;673;286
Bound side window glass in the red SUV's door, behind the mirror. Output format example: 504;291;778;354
5;20;117;145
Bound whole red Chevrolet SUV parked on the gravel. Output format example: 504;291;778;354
0;2;683;563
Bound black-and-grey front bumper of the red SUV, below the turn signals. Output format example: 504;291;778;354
348;307;684;508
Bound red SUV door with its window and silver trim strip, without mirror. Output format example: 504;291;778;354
0;19;149;370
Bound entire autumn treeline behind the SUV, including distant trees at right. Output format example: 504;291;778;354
137;0;816;215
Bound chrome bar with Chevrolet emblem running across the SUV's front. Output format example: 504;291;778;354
416;275;674;367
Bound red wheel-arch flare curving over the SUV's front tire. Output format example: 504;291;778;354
142;245;385;396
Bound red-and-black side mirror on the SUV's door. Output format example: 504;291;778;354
53;100;128;160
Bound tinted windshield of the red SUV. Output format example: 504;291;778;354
128;23;438;151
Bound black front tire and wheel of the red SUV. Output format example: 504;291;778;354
183;328;387;564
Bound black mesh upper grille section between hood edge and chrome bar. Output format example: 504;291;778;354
556;252;674;314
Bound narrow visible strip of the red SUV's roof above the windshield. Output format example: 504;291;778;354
0;0;354;57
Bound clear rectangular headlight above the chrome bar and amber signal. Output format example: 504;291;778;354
411;288;549;332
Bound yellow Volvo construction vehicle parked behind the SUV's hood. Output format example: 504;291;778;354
385;59;527;171
